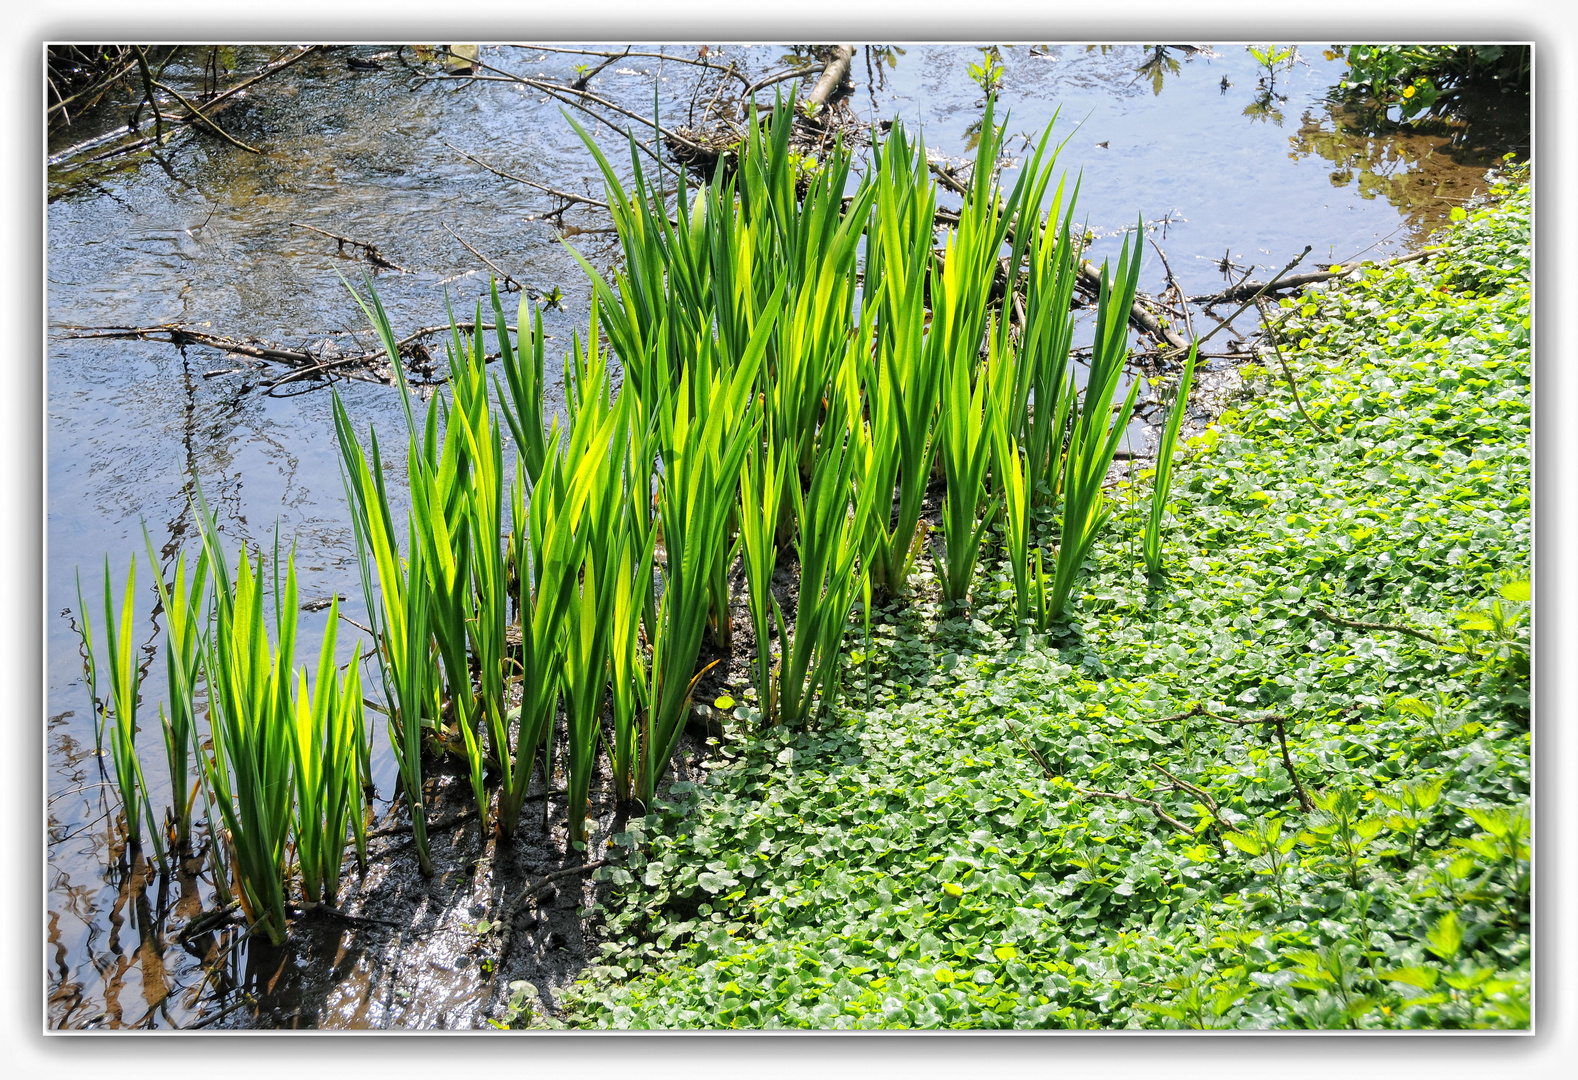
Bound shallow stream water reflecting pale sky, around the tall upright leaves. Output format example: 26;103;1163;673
46;44;1529;1028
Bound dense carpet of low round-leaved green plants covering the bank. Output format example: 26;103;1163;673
567;172;1531;1028
